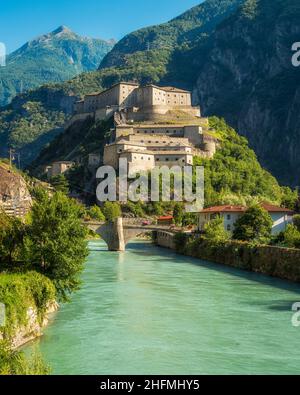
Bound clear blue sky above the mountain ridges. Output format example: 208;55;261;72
0;0;202;52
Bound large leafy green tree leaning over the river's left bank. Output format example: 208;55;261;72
25;192;88;300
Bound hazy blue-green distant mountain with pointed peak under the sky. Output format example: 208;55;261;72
0;26;114;106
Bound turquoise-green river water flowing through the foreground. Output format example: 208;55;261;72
27;241;300;374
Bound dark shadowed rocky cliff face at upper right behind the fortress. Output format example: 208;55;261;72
194;0;300;186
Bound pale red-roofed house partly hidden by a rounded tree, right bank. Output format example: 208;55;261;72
198;203;294;235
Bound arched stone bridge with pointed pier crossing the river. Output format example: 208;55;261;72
85;218;170;251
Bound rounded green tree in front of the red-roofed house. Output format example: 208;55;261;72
233;206;273;243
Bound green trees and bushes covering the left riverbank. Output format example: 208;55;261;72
0;178;88;374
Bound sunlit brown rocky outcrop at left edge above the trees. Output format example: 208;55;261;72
0;163;32;216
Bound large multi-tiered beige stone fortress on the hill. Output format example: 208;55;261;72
73;82;218;173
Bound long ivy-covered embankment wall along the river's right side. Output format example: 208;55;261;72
155;231;300;283
